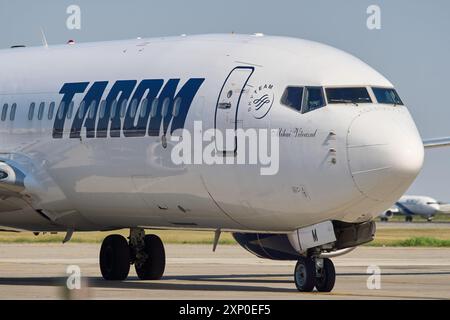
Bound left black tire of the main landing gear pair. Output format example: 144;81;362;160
100;234;130;281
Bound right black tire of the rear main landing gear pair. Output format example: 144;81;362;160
134;234;166;280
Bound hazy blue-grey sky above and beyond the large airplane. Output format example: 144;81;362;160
0;0;450;201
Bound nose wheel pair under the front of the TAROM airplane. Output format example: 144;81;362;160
294;257;336;292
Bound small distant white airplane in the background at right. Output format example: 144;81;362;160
380;195;441;222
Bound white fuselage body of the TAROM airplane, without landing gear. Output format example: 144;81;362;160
0;35;423;232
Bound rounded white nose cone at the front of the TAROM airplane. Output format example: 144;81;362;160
347;110;424;201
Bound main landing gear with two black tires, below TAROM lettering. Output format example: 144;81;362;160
100;229;166;280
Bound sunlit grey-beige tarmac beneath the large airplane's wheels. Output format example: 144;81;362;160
0;244;450;299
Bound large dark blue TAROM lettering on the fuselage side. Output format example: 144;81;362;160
53;78;205;139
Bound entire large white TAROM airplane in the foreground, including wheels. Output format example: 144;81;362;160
0;34;450;292
